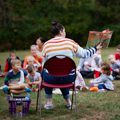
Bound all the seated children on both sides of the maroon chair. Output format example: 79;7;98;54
0;38;120;100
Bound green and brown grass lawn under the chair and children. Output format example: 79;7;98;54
0;48;120;120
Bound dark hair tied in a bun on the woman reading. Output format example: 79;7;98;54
51;21;64;37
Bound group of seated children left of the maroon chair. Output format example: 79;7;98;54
0;39;43;99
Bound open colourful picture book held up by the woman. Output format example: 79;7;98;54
86;29;113;48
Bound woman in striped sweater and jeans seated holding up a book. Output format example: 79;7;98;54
42;22;102;109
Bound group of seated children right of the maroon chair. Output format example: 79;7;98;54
75;45;120;92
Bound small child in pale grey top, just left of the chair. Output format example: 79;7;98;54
26;65;41;92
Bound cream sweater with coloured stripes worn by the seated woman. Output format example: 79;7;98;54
42;37;97;61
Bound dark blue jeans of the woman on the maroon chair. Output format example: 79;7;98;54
42;70;76;99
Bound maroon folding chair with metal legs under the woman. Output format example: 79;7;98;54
36;55;76;115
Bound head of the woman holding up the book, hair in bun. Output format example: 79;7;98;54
51;21;66;37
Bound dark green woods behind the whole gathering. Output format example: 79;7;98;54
0;0;120;51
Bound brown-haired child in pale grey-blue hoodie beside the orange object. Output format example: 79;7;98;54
90;63;114;91
